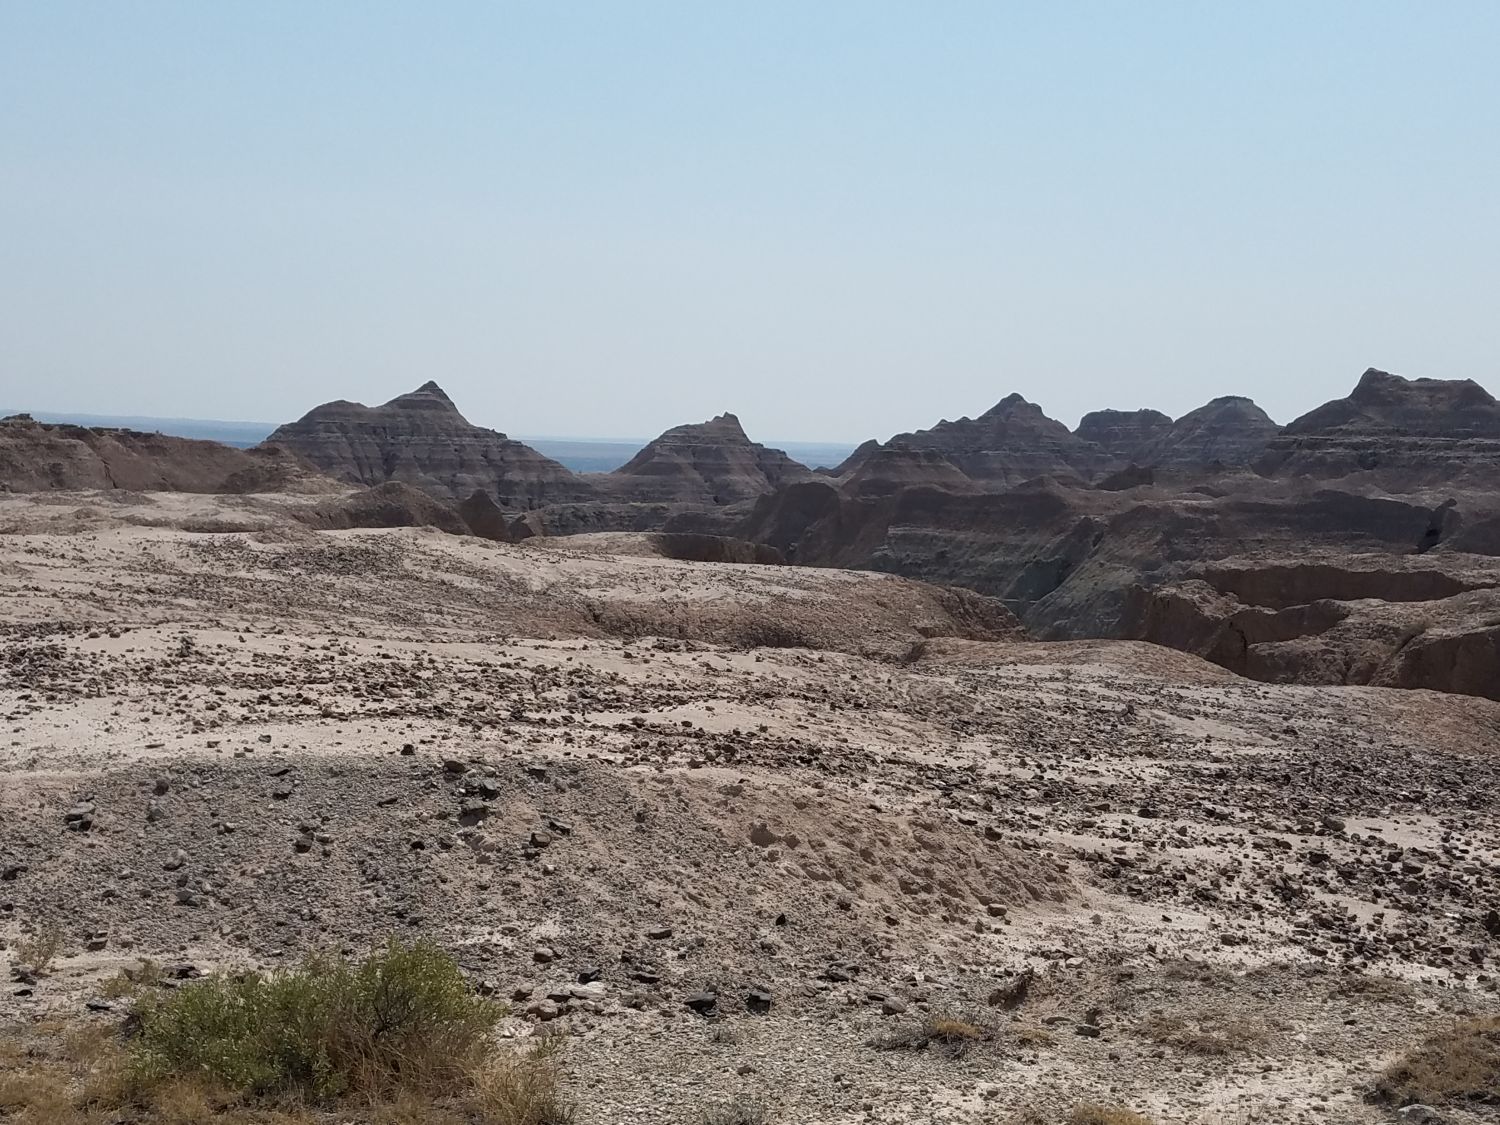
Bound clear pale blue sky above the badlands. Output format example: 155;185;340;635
0;0;1500;441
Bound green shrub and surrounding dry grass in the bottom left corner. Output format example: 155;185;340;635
0;942;573;1125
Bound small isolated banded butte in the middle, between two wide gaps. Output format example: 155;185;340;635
608;414;813;506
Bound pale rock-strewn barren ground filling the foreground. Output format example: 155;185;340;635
0;491;1500;1125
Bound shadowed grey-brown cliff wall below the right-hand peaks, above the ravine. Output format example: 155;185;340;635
735;474;1452;639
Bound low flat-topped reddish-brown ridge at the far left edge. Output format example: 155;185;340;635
0;416;338;494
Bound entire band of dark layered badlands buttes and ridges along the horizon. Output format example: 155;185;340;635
11;371;1500;705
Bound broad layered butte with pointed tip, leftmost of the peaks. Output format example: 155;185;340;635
266;383;596;509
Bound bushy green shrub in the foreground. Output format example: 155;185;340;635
131;942;503;1100
